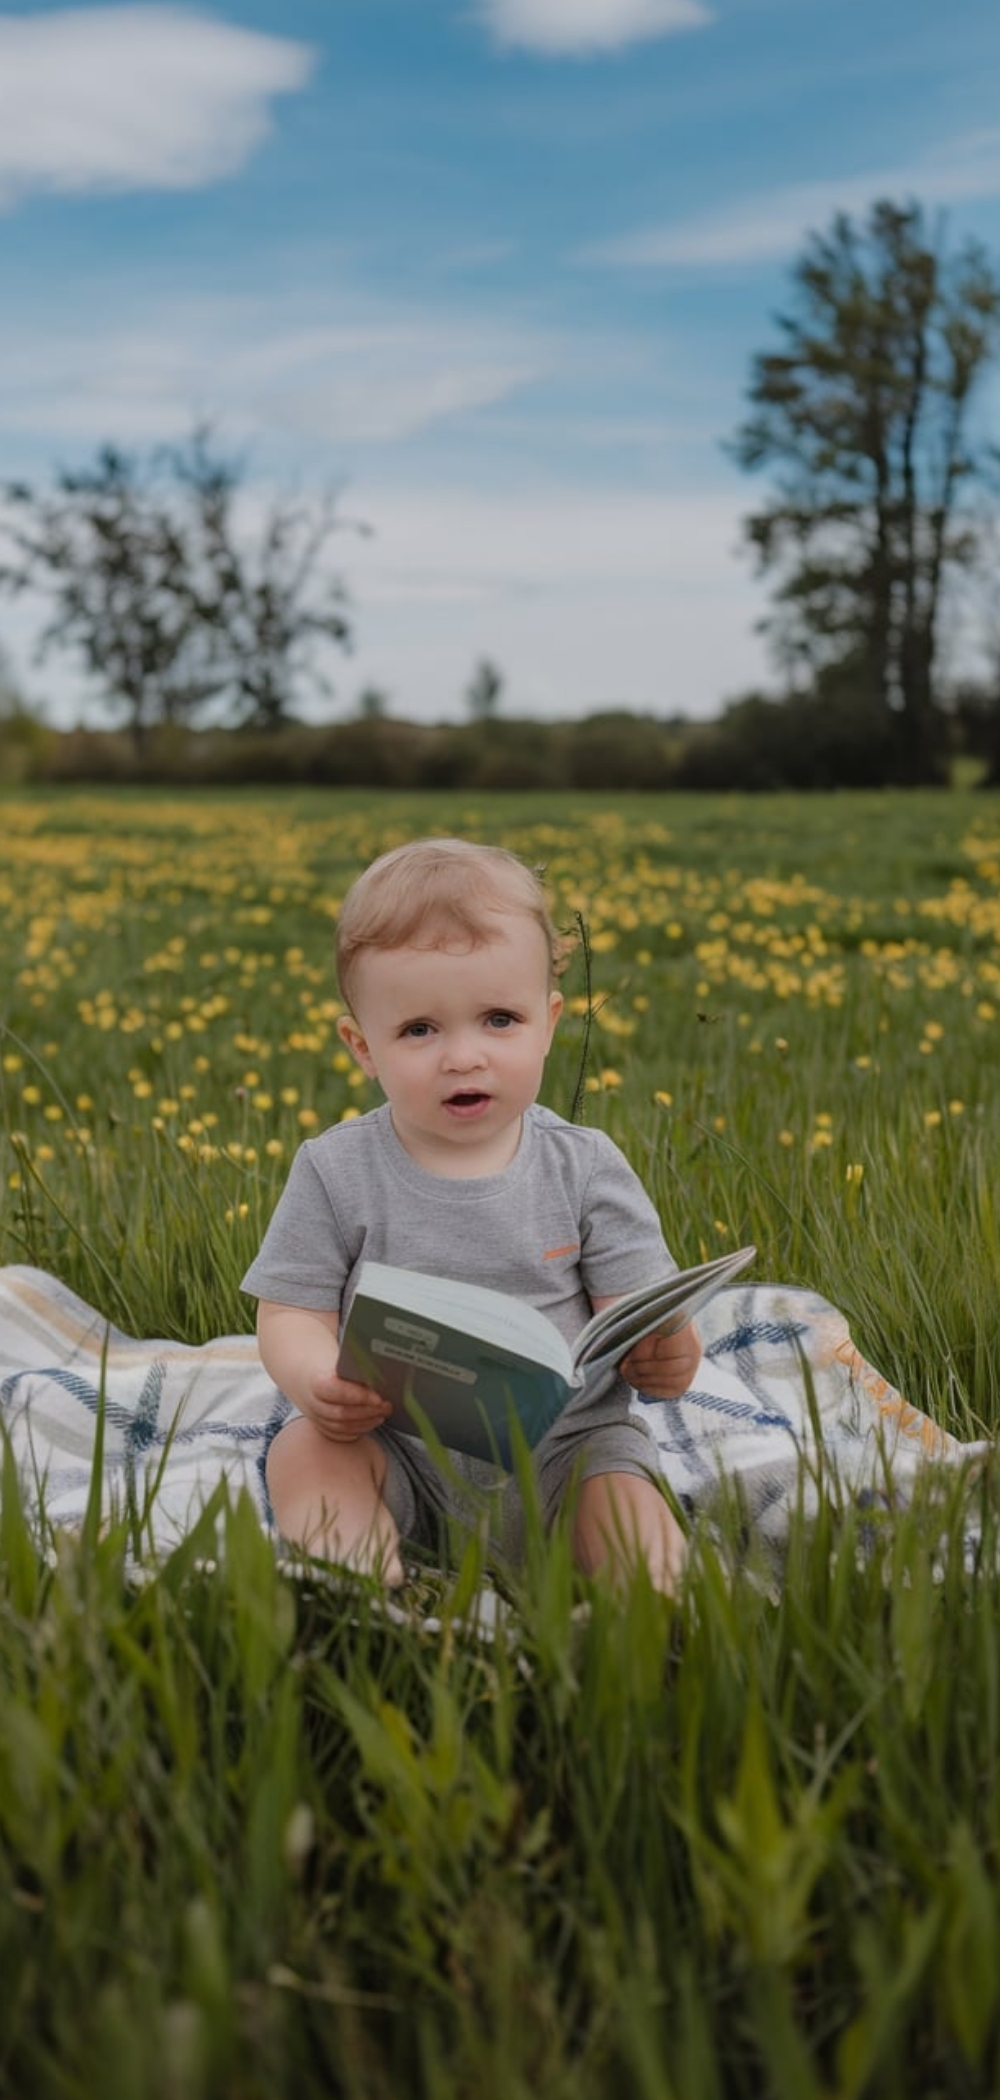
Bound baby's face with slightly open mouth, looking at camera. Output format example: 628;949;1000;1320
340;916;563;1176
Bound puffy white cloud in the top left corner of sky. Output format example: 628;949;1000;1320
0;6;313;206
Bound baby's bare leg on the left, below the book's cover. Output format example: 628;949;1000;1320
267;1415;403;1588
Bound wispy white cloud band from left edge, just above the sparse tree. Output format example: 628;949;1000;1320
0;290;559;454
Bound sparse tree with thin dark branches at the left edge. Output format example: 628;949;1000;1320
0;428;349;746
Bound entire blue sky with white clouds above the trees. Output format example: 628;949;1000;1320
0;0;1000;718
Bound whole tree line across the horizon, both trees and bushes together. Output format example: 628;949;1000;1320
0;202;1000;785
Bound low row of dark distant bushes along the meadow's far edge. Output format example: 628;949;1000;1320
11;678;1000;794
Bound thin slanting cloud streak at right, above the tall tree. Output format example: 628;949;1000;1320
580;130;1000;269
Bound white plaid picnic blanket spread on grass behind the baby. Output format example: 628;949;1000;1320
0;1264;992;1552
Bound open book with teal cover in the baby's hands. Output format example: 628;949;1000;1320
338;1247;756;1466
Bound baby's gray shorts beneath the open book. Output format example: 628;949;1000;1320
374;1384;660;1562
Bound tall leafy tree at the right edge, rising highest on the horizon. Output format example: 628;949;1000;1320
733;202;1000;781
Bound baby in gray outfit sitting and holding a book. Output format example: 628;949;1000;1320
244;838;702;1590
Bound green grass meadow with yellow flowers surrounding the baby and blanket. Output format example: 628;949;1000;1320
0;790;1000;2100
